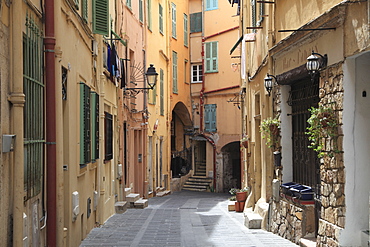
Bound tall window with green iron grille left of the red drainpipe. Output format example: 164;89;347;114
23;16;45;200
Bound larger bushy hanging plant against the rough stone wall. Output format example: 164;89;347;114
306;105;339;158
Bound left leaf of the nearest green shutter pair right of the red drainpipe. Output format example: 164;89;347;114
80;82;91;168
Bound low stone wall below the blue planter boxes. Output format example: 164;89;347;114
270;199;315;244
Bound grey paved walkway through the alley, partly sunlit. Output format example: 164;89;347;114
80;191;297;247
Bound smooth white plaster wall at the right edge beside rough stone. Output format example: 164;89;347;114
340;53;370;246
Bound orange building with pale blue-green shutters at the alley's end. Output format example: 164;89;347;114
187;0;242;192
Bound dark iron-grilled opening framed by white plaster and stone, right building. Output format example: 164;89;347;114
288;78;320;188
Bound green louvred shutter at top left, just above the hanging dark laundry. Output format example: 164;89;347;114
93;0;109;36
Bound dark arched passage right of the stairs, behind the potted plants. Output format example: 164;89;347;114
221;142;241;192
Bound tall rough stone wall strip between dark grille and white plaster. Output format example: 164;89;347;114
316;63;346;246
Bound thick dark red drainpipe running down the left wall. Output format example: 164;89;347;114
44;0;57;247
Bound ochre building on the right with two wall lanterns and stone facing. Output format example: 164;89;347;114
238;1;370;246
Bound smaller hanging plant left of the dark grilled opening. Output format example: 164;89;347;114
260;117;280;149
